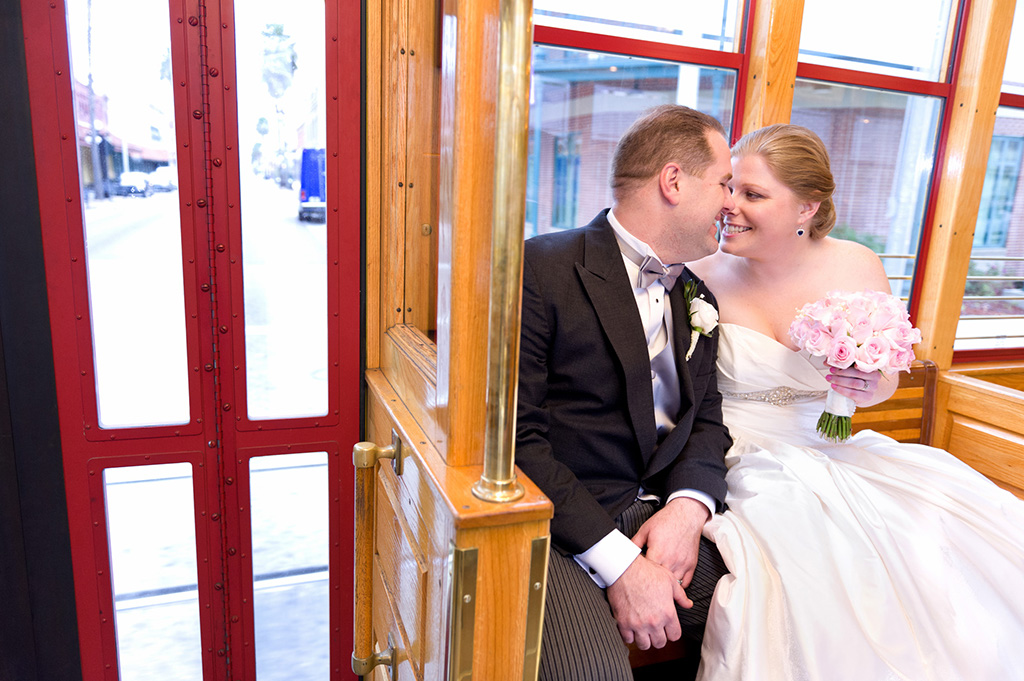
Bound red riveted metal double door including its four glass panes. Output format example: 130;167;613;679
22;0;361;681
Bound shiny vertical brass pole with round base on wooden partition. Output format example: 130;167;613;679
473;0;534;502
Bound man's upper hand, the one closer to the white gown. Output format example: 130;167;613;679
633;497;711;588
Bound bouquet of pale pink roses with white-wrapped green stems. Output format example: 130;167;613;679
790;291;921;442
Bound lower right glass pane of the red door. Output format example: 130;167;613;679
249;452;331;681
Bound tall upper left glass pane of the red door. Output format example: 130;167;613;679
68;0;188;428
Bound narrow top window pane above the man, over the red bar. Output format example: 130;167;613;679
534;0;740;52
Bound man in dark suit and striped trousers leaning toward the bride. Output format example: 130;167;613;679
516;104;732;681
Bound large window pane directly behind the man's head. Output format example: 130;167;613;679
525;45;736;238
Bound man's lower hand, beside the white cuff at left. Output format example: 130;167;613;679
607;556;693;650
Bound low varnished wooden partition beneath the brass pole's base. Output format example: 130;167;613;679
367;371;552;681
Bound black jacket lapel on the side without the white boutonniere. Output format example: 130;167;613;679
575;213;655;460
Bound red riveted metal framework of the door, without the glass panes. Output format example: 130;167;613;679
22;0;362;681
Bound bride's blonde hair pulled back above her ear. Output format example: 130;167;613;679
732;124;836;239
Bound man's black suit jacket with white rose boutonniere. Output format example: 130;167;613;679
515;210;732;554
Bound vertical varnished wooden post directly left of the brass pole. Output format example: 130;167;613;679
437;0;500;466
